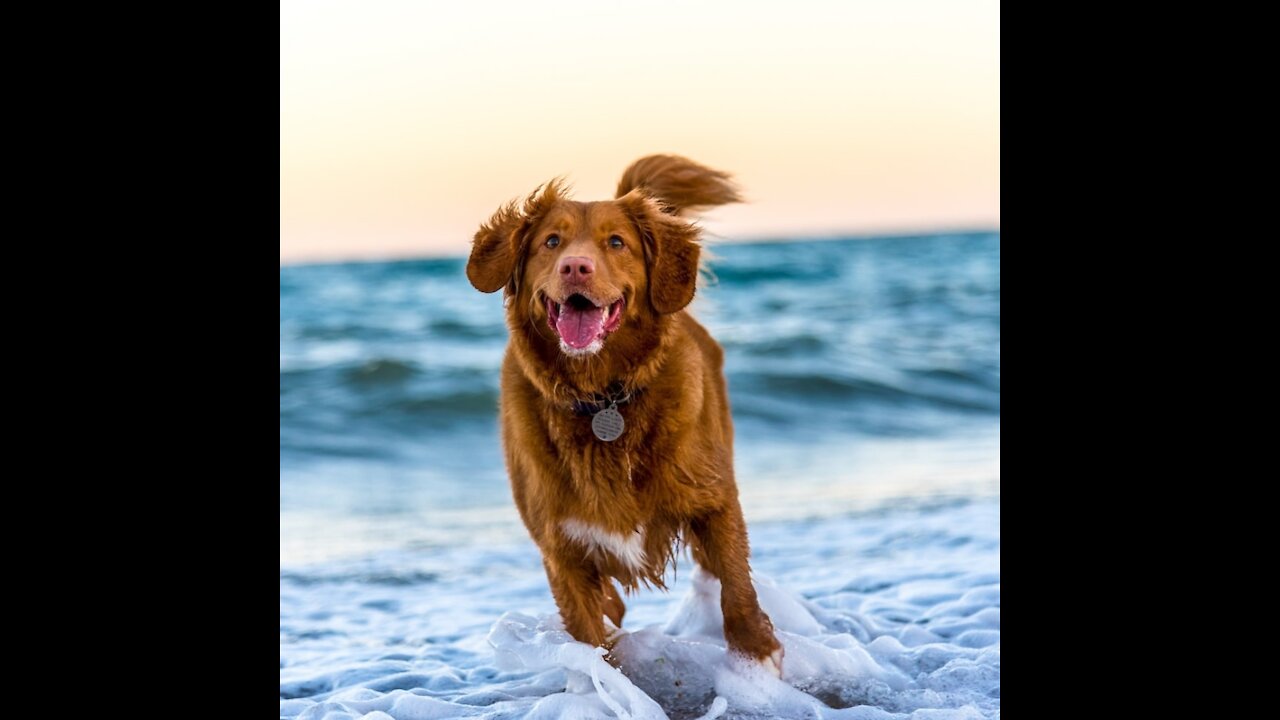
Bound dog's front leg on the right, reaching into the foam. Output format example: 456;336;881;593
690;501;782;675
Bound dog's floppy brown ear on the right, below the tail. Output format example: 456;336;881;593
617;190;701;315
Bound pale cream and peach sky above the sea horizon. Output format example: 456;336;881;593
280;0;1000;263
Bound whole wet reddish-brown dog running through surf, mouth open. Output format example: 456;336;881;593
467;155;782;674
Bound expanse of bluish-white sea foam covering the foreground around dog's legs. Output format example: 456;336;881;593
280;497;1000;720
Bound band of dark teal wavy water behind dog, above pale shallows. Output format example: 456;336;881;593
280;233;1000;462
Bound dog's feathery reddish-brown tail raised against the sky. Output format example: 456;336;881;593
617;155;742;215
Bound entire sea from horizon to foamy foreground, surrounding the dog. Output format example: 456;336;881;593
280;233;1000;719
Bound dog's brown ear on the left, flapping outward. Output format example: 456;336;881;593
467;178;564;295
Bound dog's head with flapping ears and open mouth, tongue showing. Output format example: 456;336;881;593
467;181;700;357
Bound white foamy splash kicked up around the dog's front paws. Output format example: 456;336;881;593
489;570;998;717
